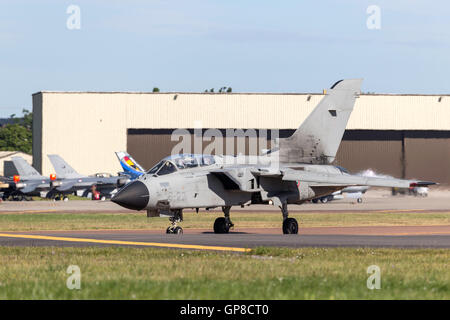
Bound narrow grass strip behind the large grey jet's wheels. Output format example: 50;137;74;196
0;212;450;231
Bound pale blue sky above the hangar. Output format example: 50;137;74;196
0;0;450;117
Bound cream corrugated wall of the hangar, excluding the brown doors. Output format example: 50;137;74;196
33;92;450;179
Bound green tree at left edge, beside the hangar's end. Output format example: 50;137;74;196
0;109;33;154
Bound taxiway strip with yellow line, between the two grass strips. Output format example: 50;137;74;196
0;225;450;252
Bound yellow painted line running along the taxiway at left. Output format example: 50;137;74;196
0;233;251;252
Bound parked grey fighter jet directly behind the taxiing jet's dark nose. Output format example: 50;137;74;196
48;154;130;196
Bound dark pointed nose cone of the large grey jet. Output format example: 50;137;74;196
111;181;149;210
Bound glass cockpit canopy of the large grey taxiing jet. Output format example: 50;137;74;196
147;154;216;176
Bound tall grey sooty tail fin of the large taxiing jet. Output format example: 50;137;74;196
279;79;362;164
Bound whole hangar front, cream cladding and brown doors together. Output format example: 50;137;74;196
33;91;450;183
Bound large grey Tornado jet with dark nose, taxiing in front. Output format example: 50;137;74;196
111;79;434;234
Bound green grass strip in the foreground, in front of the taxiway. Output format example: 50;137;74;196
0;247;450;299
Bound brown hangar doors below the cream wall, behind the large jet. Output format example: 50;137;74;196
127;129;450;183
